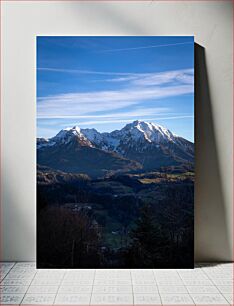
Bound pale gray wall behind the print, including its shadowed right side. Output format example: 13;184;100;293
1;1;232;261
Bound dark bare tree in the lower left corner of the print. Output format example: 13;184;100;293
37;207;101;268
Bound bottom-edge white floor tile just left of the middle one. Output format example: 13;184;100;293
54;294;91;305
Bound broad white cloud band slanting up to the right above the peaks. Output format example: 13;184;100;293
37;84;193;117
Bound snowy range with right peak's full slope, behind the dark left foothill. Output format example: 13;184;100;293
37;120;194;170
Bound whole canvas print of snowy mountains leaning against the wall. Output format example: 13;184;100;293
37;36;194;268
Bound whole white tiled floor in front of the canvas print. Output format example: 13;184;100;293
0;262;233;306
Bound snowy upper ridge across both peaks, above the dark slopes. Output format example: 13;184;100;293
37;120;191;156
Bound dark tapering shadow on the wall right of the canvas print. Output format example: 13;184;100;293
195;44;232;261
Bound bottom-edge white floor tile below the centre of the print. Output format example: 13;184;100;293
90;294;133;305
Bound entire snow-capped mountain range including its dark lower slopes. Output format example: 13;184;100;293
37;120;194;178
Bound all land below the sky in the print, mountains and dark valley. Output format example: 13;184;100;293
37;121;194;268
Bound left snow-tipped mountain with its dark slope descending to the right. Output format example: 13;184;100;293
37;127;142;177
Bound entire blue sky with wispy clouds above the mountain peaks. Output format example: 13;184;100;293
37;36;194;141
